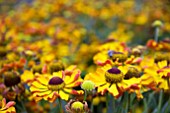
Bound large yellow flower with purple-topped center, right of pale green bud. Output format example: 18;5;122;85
85;65;140;97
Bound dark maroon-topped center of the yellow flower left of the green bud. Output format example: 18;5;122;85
48;77;65;91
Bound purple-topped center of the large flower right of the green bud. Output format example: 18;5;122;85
105;67;124;83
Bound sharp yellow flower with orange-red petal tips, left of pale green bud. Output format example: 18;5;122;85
30;66;83;102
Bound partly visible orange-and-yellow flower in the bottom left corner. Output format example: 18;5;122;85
0;98;16;113
